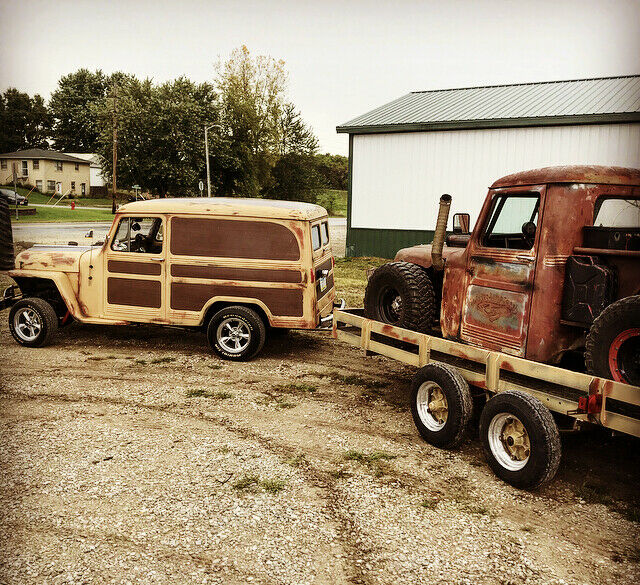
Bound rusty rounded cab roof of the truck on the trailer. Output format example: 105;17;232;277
491;165;640;189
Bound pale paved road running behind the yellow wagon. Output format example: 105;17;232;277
13;217;347;257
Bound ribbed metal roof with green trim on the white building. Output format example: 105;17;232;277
336;75;640;134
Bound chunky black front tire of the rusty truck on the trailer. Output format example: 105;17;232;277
364;262;436;331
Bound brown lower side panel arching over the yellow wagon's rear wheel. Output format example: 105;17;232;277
171;282;304;317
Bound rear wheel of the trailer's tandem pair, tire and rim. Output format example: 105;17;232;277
480;390;561;489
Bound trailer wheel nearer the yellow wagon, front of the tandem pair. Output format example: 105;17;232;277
411;363;473;449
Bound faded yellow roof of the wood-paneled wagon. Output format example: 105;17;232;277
118;197;327;220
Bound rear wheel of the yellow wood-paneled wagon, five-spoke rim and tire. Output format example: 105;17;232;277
207;305;266;361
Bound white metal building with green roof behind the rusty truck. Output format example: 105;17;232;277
337;75;640;258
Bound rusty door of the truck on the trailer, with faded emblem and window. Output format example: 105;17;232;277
460;186;545;356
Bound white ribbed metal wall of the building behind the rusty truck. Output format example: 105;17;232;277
351;124;640;230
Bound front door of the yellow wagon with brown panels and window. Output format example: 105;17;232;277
104;216;166;322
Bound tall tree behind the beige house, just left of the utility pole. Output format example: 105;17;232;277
49;69;109;152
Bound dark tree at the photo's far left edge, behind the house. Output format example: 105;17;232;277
0;88;51;152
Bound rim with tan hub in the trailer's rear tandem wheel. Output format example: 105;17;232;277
488;412;531;471
